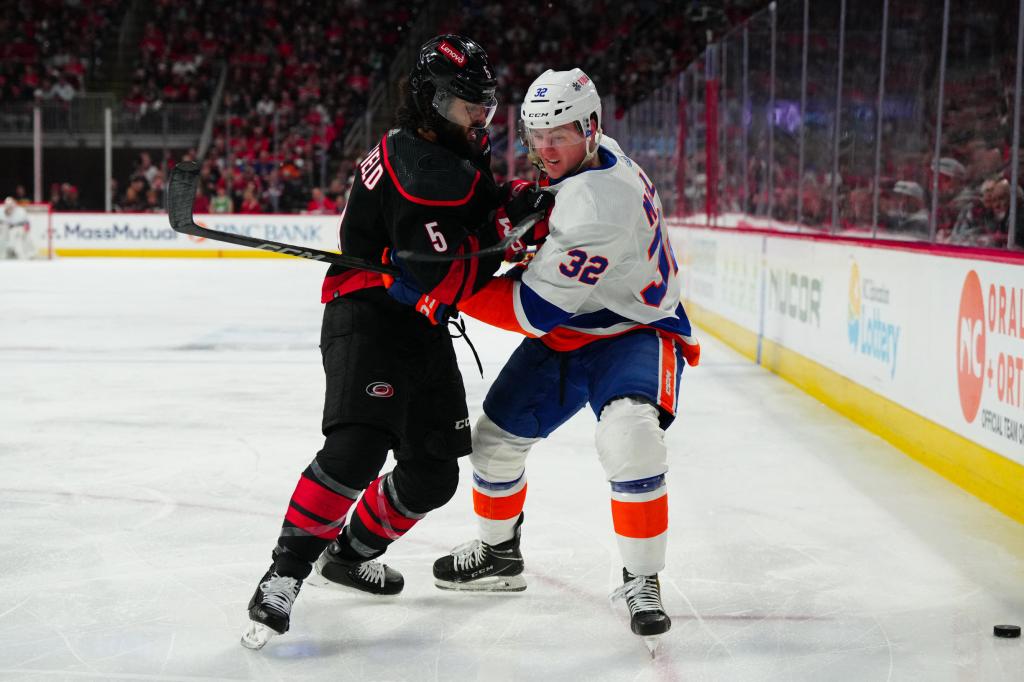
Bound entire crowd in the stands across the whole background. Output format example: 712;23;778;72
0;0;1024;247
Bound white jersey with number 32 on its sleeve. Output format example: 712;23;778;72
513;136;693;349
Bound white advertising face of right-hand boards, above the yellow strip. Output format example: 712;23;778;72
672;227;1024;464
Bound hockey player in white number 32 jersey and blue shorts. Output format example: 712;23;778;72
434;69;699;637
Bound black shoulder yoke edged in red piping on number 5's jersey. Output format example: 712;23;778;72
383;128;480;206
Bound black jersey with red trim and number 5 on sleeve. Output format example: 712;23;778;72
323;128;502;305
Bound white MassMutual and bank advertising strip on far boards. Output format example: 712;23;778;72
51;213;341;254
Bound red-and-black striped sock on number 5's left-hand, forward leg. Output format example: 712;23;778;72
274;460;359;579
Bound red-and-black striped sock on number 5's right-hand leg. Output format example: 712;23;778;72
339;472;426;560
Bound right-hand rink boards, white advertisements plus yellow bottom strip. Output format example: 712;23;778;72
670;224;1024;522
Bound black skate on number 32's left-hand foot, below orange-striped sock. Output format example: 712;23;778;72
434;514;526;592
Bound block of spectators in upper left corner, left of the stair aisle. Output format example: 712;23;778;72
0;0;128;104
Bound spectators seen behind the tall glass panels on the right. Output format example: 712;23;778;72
704;2;1024;248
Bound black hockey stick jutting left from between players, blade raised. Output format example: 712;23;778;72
167;161;401;274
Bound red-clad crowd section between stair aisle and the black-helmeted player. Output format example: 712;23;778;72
126;0;423;213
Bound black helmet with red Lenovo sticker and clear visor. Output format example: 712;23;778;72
409;33;498;128
